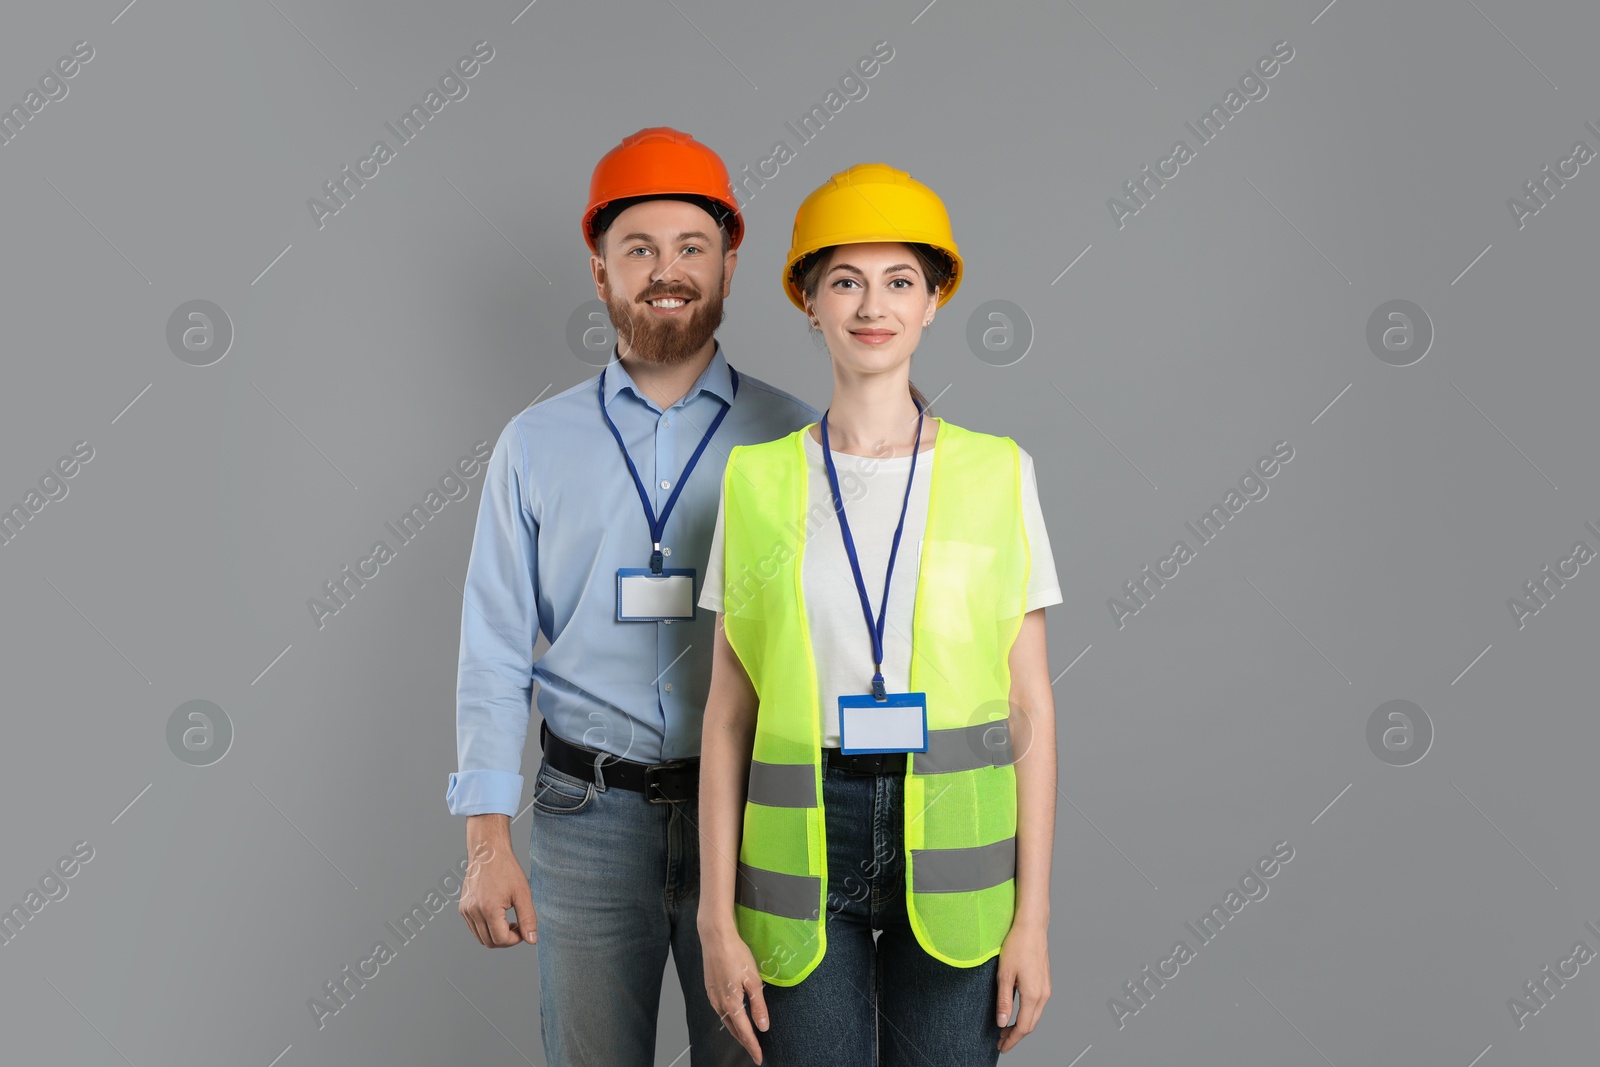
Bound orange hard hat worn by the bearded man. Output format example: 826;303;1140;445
584;126;744;253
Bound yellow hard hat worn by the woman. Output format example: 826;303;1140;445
782;163;962;310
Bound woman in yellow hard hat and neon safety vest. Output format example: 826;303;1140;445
698;163;1061;1067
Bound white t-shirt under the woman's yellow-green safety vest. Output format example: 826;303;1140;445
699;430;1062;749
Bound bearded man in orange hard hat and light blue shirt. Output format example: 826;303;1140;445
446;128;821;1067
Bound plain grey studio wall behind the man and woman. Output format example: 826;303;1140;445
0;0;1600;1067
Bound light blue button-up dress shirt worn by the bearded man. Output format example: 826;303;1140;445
445;342;822;816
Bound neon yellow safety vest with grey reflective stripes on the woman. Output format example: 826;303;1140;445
723;419;1029;985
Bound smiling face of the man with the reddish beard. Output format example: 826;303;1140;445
589;200;739;366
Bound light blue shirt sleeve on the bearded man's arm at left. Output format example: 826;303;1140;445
445;421;539;816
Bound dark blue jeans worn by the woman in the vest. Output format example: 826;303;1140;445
755;749;1000;1067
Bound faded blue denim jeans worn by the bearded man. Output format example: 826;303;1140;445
528;758;754;1067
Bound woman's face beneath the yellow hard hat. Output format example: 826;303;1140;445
808;242;939;383
